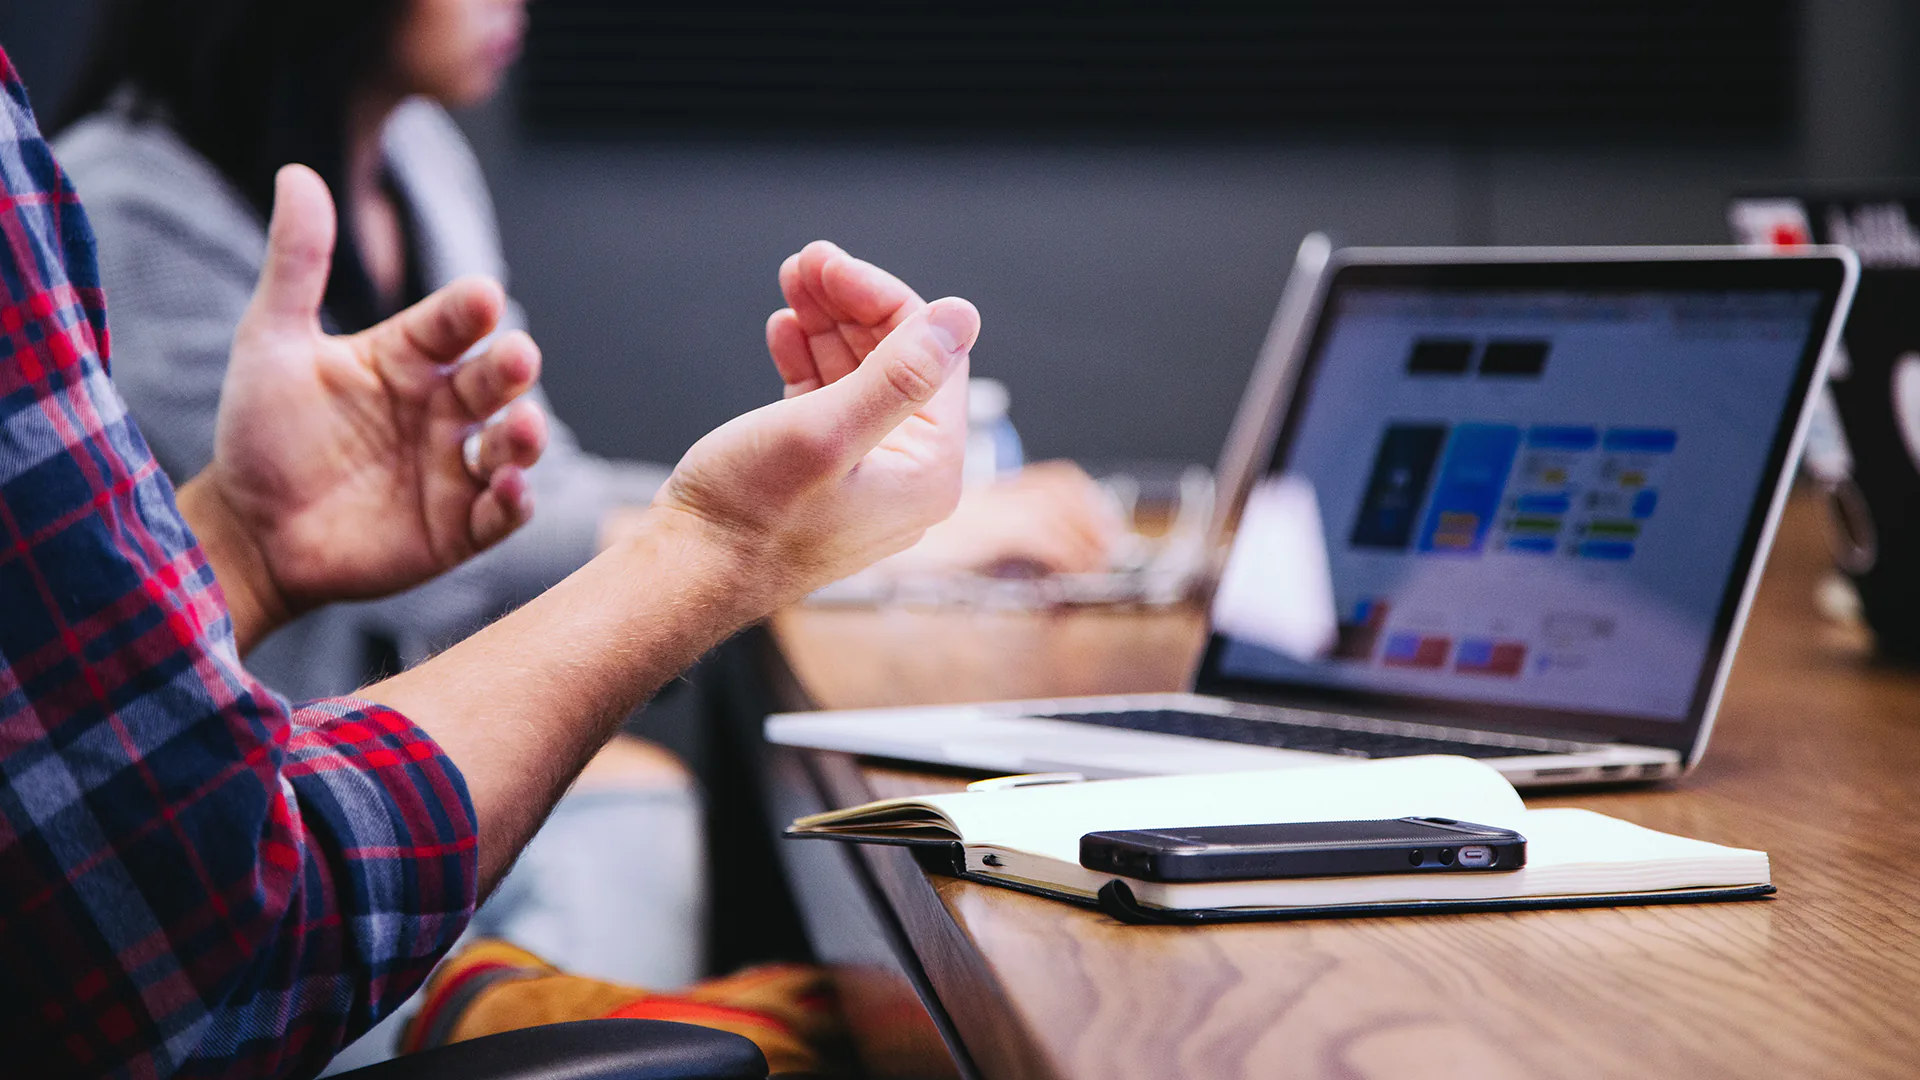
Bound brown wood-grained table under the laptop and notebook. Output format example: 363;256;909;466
768;496;1920;1080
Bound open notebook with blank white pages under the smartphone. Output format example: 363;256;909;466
787;757;1774;922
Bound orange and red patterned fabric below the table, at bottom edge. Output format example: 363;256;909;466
401;940;843;1074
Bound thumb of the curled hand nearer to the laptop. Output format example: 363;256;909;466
795;296;979;455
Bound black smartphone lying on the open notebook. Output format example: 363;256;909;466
1081;817;1526;882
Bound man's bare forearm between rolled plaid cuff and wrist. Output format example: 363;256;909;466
361;509;776;892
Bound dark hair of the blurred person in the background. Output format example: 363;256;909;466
56;0;405;331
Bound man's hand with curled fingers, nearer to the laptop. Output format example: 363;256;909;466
655;244;979;611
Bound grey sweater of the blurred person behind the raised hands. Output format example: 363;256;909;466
54;100;666;698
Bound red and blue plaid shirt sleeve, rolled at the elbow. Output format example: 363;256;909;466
0;46;476;1078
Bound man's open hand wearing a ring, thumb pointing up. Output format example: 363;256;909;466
204;165;547;611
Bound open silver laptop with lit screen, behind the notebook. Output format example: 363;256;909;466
766;248;1859;786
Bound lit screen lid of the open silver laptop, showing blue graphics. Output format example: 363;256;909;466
1196;248;1857;763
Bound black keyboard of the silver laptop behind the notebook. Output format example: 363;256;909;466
1041;709;1594;757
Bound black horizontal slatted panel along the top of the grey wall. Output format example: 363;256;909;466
522;0;1795;136
